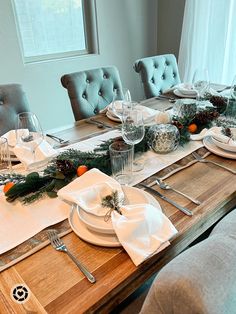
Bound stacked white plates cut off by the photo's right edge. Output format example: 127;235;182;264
203;128;236;159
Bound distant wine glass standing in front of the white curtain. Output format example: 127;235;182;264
192;68;209;101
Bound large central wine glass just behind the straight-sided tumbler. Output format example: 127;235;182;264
122;109;145;172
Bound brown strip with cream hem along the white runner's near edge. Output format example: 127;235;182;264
0;147;210;272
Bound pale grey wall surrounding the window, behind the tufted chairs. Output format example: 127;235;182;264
0;0;158;130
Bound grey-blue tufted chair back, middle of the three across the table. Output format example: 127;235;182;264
61;66;122;120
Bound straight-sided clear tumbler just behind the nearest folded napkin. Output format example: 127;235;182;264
109;141;133;185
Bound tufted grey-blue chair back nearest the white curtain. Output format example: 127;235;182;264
134;54;180;98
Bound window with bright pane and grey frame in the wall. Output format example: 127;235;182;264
13;0;96;62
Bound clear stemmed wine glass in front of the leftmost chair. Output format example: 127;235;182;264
16;112;44;169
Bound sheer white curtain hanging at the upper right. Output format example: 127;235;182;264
178;0;236;84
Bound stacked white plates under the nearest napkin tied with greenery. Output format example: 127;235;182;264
69;186;159;247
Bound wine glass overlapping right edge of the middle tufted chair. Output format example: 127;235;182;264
112;88;132;121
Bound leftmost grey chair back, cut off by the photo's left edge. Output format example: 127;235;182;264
0;84;29;136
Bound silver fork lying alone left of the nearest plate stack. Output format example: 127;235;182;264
47;230;96;283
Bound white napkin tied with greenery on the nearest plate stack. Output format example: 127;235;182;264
58;169;177;266
